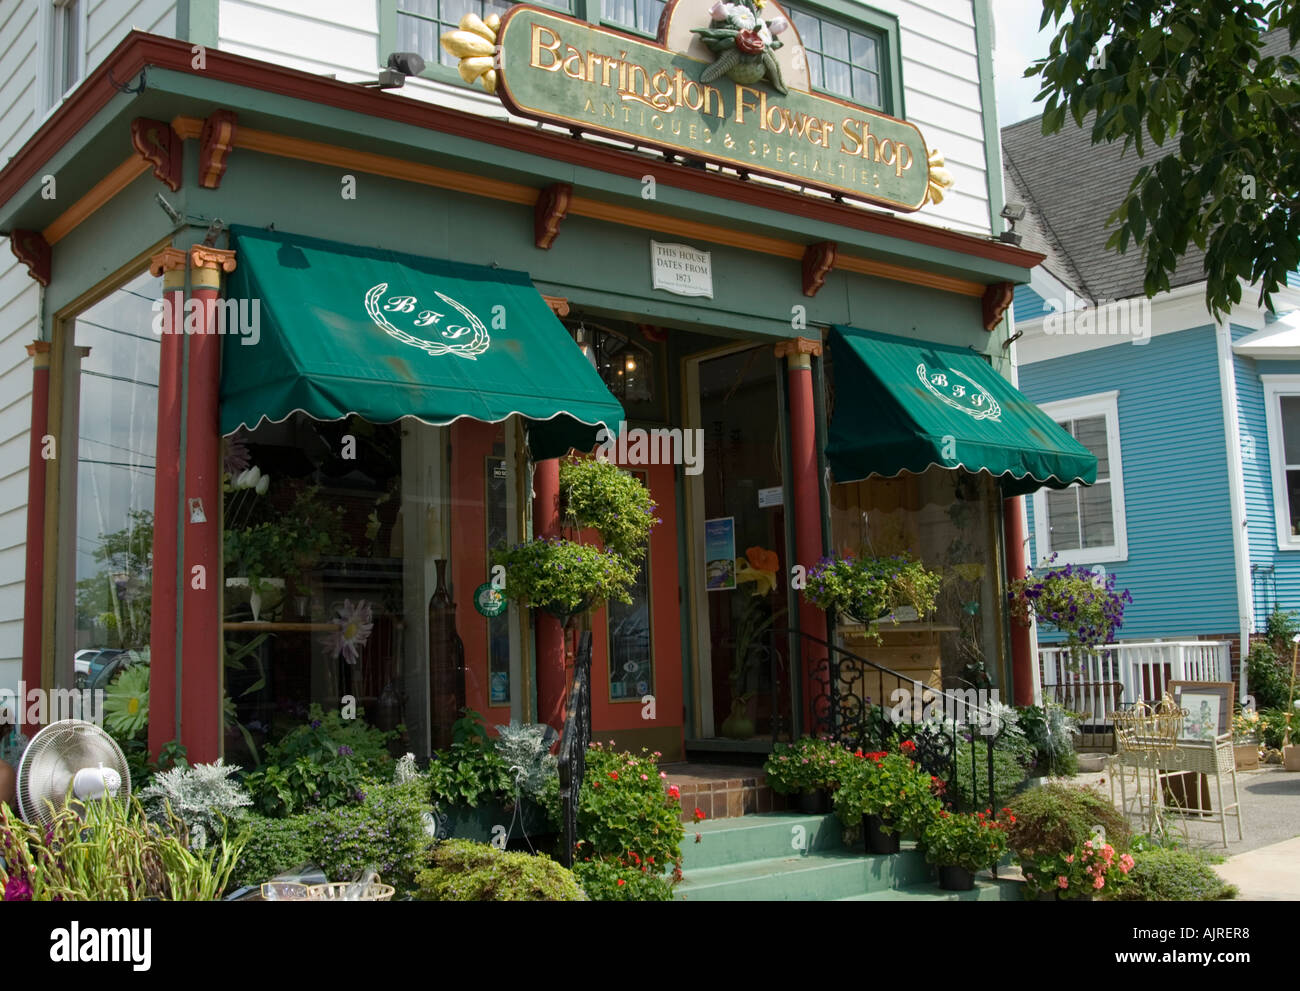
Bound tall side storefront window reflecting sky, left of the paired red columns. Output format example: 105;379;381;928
73;266;161;683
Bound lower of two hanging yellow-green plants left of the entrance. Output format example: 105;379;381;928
493;537;640;616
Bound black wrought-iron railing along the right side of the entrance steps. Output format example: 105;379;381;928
770;629;1002;810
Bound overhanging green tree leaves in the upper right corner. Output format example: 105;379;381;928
1026;0;1300;313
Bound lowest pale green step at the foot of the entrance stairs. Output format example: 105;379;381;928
677;844;935;901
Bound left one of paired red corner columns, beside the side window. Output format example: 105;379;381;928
150;247;187;760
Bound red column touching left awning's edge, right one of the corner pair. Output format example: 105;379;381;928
179;244;235;763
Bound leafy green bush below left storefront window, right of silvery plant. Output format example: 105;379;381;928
244;705;394;817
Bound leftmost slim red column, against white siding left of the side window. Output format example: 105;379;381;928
20;341;57;686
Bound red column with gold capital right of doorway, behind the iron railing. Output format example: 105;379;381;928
776;337;829;732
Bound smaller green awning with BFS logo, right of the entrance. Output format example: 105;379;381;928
826;326;1097;496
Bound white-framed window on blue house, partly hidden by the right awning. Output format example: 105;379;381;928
1034;393;1128;564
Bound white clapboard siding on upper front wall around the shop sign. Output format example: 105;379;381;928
218;0;989;234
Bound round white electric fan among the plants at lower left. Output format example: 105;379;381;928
18;719;131;826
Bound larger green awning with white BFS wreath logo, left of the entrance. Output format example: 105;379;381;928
221;226;623;460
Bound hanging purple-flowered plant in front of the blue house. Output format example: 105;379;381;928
1006;554;1134;660
